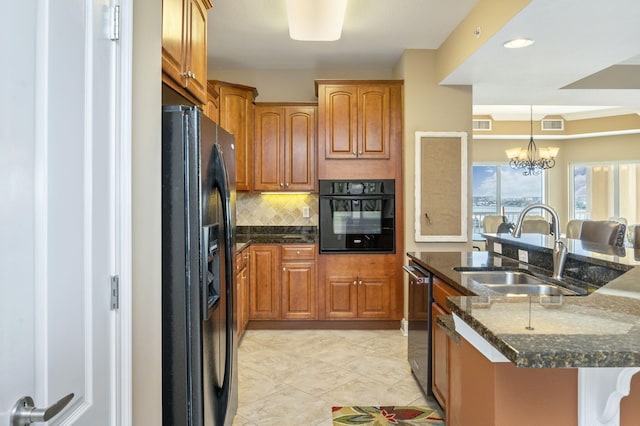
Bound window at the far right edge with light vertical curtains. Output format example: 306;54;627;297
570;162;640;224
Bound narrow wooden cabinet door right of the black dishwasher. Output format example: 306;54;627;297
431;303;449;411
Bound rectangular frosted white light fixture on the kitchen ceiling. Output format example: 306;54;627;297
287;0;347;41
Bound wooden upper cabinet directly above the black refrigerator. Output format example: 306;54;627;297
162;0;211;104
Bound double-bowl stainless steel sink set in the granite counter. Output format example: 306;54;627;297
458;270;577;296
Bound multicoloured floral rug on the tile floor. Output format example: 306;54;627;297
331;406;444;426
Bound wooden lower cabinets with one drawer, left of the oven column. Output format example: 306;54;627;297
249;244;317;320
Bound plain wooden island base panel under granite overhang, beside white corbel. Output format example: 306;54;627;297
446;338;578;426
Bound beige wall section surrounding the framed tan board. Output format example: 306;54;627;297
394;50;472;255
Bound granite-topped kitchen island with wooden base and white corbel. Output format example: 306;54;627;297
408;234;640;426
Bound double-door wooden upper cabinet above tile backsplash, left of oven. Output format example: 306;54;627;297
253;103;317;191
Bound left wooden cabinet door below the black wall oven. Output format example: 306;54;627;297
325;276;358;319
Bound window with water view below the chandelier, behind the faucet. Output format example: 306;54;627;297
473;164;545;234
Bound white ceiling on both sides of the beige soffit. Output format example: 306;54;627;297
208;0;640;120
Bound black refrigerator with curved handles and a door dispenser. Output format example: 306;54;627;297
162;105;238;426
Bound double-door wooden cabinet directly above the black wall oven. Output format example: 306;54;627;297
316;81;401;159
